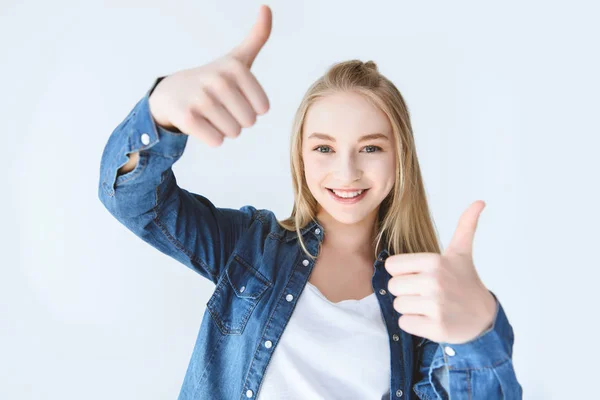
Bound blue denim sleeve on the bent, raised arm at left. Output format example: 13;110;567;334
98;76;258;283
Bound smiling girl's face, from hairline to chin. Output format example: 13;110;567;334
302;92;396;224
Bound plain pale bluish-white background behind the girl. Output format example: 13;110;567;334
0;0;600;400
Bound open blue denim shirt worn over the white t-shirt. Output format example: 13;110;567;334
98;77;522;400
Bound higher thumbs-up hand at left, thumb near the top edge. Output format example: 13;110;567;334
148;5;272;147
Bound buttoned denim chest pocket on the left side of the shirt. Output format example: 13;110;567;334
206;254;272;335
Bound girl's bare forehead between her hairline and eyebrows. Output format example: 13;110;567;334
303;92;392;138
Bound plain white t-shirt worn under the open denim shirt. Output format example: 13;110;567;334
257;282;391;400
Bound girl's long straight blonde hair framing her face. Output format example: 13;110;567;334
278;60;440;259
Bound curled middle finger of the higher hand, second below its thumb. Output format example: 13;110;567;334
209;78;256;128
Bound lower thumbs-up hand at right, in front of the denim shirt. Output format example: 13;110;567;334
385;201;496;344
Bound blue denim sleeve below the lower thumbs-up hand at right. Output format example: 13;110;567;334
413;291;523;400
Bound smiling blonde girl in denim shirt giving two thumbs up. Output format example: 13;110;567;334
98;6;522;400
